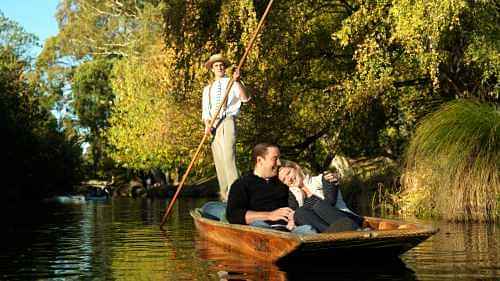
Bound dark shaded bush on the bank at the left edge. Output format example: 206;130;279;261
0;47;81;203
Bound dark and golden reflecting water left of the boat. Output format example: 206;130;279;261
0;199;216;280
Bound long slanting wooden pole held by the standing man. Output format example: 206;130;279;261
160;0;274;230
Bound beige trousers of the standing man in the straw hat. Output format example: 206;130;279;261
212;116;238;202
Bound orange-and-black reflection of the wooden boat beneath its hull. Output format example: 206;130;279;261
196;236;417;281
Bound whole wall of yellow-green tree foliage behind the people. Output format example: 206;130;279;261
33;0;500;217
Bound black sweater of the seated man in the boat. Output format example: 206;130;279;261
226;173;288;224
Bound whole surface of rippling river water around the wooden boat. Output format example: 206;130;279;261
0;198;500;280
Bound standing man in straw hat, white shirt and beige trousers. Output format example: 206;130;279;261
202;54;250;202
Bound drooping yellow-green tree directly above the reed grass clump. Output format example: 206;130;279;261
333;0;500;161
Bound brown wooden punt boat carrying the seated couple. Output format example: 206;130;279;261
190;209;438;262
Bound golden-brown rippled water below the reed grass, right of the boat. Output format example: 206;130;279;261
403;223;500;280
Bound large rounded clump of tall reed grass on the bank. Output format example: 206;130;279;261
399;100;500;222
